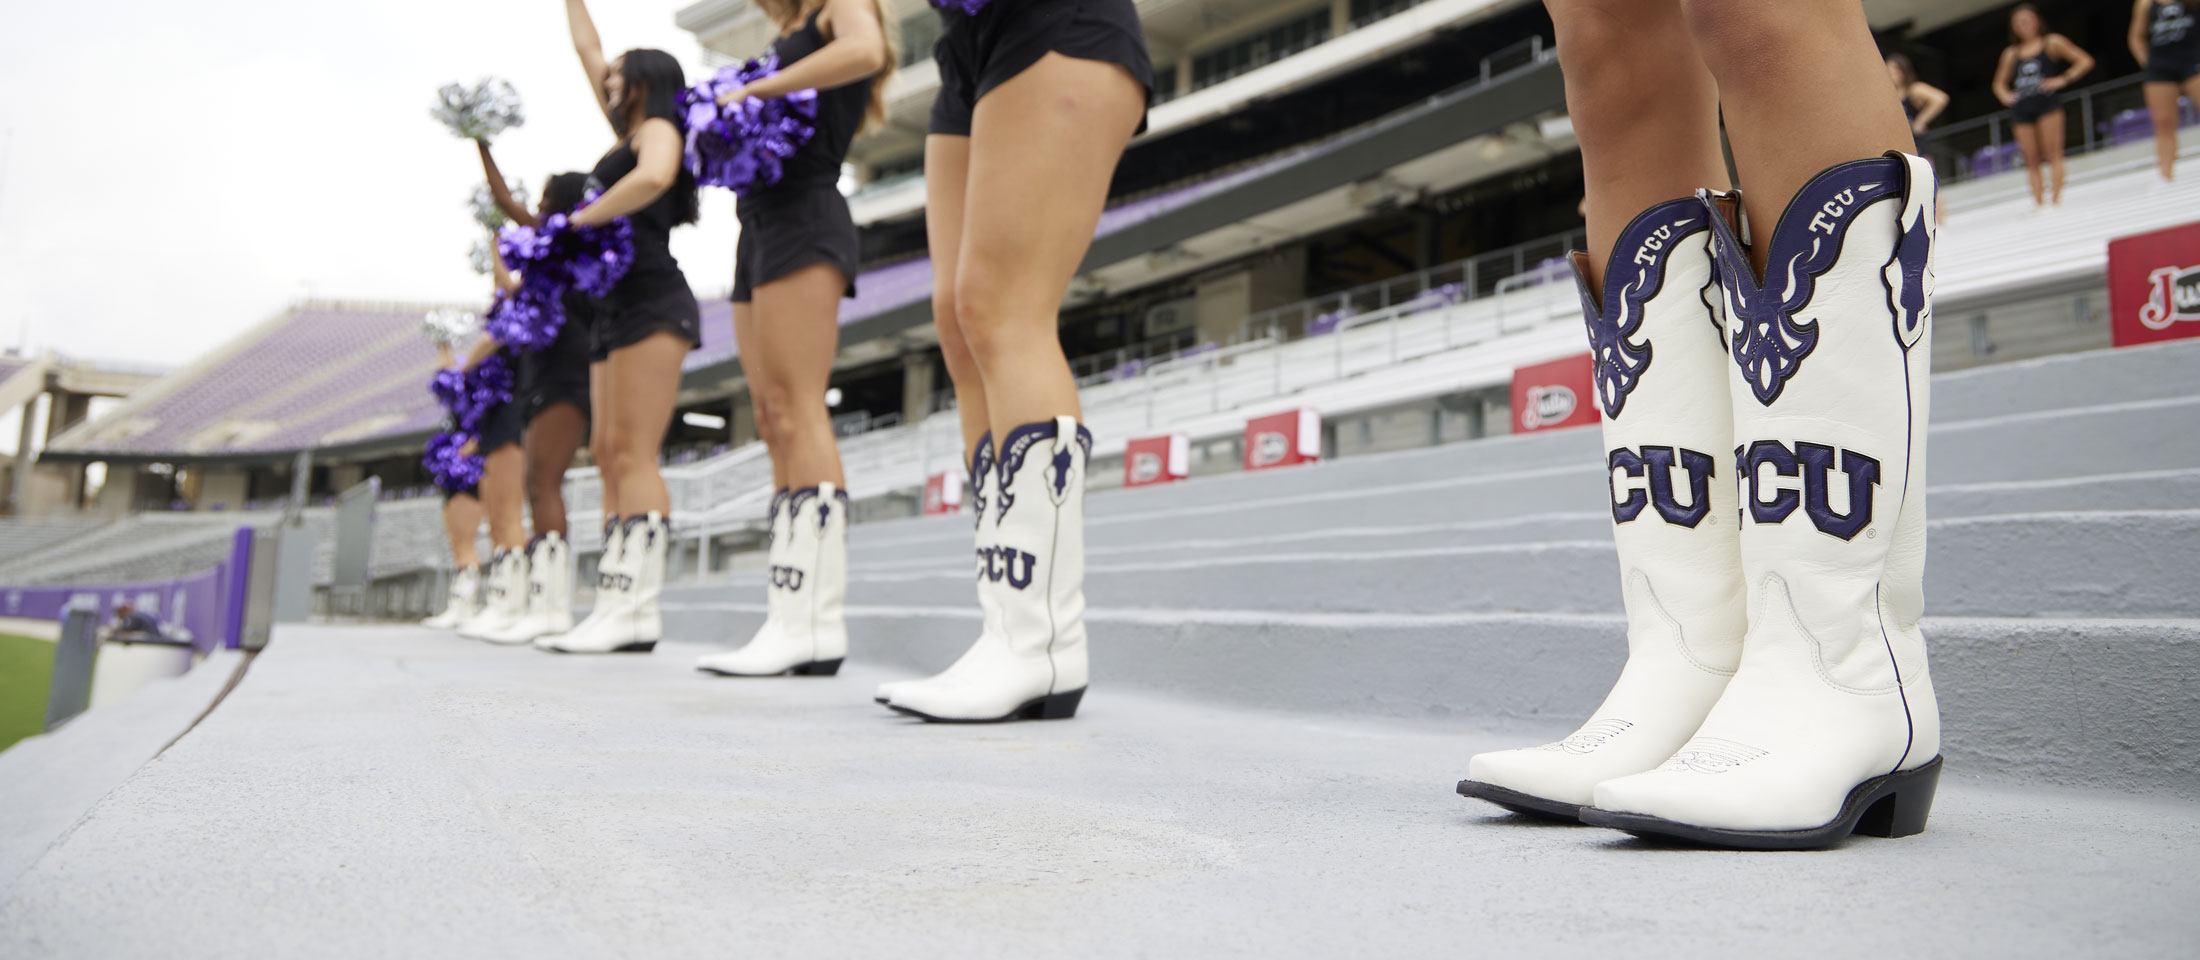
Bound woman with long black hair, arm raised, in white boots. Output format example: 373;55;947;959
535;0;702;654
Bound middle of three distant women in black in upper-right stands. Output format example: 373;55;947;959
1993;4;2092;207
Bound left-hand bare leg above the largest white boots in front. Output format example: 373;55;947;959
1544;0;1729;291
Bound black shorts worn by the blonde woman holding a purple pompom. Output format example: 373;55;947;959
733;183;862;304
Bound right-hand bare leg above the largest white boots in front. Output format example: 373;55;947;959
1681;0;1916;269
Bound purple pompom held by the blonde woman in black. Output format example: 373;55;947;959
680;55;818;196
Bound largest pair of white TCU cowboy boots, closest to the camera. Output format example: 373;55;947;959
1459;154;1940;850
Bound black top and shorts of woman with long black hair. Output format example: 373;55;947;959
587;141;702;361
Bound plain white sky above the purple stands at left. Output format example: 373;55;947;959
0;0;737;374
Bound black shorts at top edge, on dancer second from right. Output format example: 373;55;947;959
931;0;1153;137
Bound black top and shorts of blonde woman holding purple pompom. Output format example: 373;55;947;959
733;9;876;304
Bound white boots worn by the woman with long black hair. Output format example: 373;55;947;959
532;511;671;654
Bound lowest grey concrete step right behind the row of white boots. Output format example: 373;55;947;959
664;603;2200;799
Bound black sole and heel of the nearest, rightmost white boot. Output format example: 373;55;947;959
1582;757;1940;850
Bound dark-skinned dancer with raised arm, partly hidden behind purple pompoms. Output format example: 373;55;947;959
477;154;594;643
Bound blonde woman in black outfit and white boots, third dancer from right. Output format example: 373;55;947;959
695;0;893;676
